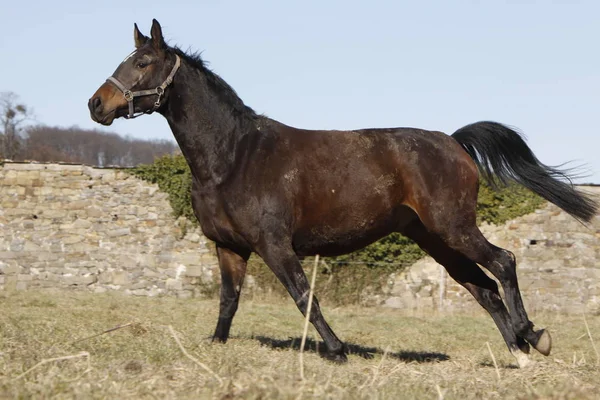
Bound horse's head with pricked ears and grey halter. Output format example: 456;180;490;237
88;20;180;125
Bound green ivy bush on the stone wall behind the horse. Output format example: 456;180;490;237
133;155;544;303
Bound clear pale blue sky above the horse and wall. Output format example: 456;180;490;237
0;0;600;183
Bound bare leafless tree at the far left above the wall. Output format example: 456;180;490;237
0;92;32;159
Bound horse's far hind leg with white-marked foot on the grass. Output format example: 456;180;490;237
402;220;530;368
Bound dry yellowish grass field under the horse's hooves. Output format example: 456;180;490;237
0;292;600;399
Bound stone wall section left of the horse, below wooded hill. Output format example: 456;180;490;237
0;163;218;297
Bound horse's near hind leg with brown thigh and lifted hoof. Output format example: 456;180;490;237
405;142;552;355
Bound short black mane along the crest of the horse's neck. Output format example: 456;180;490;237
170;47;259;119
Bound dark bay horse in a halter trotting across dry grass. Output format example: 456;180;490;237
88;20;598;366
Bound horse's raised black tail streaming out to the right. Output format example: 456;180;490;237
452;121;598;222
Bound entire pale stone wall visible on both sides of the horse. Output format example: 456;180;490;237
0;162;600;313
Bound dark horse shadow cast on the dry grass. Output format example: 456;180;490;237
253;336;450;363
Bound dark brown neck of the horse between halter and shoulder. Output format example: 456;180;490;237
164;65;252;185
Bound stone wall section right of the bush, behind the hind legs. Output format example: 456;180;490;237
382;186;600;314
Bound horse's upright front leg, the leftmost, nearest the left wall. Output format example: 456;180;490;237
213;244;250;343
